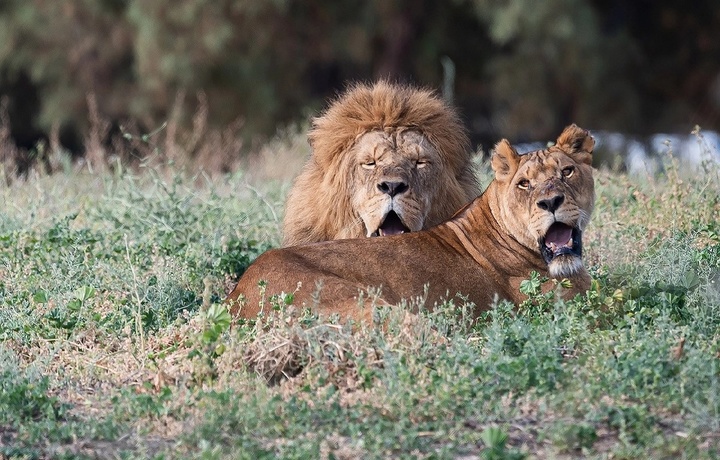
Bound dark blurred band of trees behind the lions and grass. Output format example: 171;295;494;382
0;0;720;169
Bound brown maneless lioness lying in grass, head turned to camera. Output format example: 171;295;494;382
227;125;595;321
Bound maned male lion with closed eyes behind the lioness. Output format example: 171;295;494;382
283;81;480;246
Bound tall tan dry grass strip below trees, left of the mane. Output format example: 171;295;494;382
0;92;310;190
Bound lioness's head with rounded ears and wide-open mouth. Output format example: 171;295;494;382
492;125;595;278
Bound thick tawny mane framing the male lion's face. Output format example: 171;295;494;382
283;81;480;246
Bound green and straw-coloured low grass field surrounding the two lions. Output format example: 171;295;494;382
0;132;720;459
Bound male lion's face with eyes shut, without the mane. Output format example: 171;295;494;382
352;129;443;236
